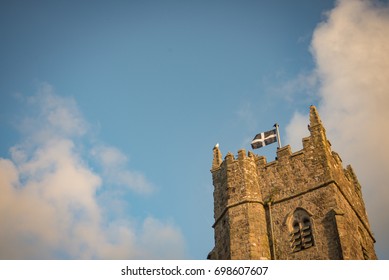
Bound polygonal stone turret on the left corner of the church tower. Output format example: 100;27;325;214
211;150;270;259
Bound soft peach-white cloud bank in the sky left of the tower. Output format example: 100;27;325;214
0;84;185;259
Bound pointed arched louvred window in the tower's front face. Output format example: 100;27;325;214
289;208;314;252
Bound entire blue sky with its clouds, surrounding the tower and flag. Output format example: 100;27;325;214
0;0;389;259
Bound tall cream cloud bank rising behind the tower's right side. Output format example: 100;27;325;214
287;0;389;258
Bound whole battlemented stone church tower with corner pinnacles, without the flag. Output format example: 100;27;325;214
208;106;377;260
